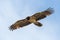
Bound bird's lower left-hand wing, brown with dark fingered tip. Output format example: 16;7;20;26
9;19;30;31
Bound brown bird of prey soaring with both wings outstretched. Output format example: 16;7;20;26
9;8;53;31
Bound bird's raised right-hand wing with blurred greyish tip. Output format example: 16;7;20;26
32;8;53;20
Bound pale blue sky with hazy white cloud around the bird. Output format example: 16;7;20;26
0;0;60;40
